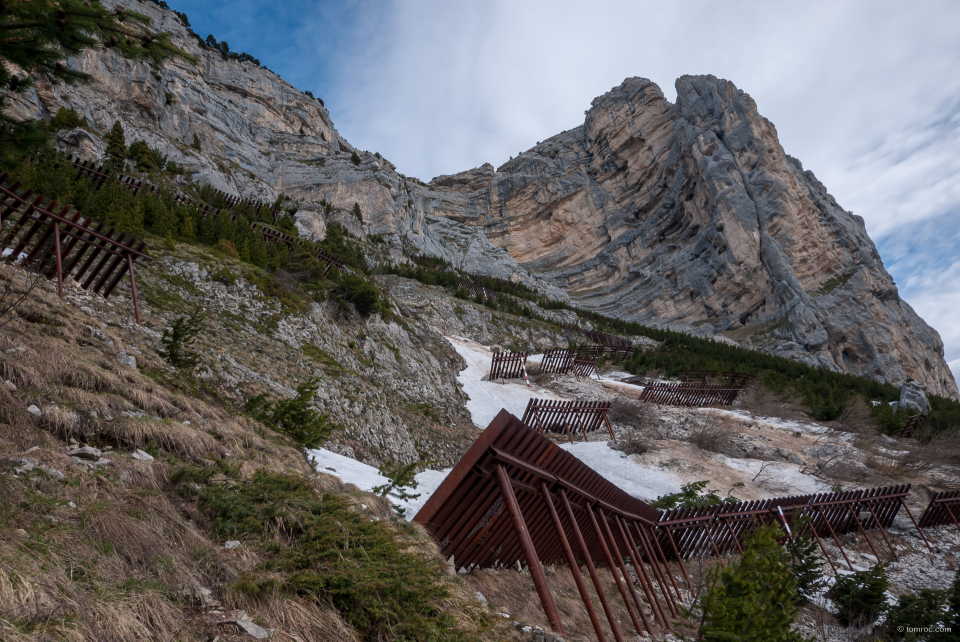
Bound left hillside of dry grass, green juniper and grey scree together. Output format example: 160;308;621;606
0;248;516;641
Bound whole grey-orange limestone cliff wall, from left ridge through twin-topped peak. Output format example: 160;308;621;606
5;0;958;397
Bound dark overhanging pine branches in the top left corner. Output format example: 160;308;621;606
0;0;196;159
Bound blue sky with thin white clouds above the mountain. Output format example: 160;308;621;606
168;0;960;379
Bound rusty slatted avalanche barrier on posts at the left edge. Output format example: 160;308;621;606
0;173;151;325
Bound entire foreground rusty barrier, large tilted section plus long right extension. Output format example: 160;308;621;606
414;410;932;642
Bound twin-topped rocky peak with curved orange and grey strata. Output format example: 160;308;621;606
434;76;957;397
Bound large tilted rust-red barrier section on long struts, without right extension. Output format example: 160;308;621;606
414;410;675;642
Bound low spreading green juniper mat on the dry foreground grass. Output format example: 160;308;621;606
199;471;483;642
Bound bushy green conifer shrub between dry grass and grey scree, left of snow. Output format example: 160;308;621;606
244;378;340;448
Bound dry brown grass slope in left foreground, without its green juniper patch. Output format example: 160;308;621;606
0;266;506;640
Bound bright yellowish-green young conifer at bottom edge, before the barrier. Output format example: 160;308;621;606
698;524;804;642
